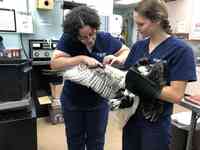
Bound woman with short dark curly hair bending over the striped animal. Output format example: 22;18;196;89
51;6;129;150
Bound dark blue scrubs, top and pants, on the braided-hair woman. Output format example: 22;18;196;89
123;36;196;150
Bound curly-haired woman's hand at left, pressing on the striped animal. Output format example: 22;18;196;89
81;56;103;68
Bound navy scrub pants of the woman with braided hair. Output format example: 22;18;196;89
122;113;171;150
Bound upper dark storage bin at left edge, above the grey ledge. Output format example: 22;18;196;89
0;59;31;102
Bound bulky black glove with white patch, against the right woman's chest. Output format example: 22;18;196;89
125;60;166;100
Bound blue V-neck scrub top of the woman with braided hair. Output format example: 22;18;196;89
125;36;196;116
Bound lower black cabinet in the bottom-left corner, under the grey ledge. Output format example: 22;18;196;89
0;99;37;150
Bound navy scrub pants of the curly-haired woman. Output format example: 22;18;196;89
64;107;109;150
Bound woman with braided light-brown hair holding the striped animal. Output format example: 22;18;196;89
123;0;196;150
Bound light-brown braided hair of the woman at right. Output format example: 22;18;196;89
134;0;172;34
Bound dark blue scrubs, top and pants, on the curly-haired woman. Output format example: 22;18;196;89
57;32;122;150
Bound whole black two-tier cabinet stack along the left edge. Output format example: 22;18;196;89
0;59;37;150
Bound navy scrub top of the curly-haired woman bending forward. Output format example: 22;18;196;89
57;32;122;110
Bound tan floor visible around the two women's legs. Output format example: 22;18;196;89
38;105;188;150
